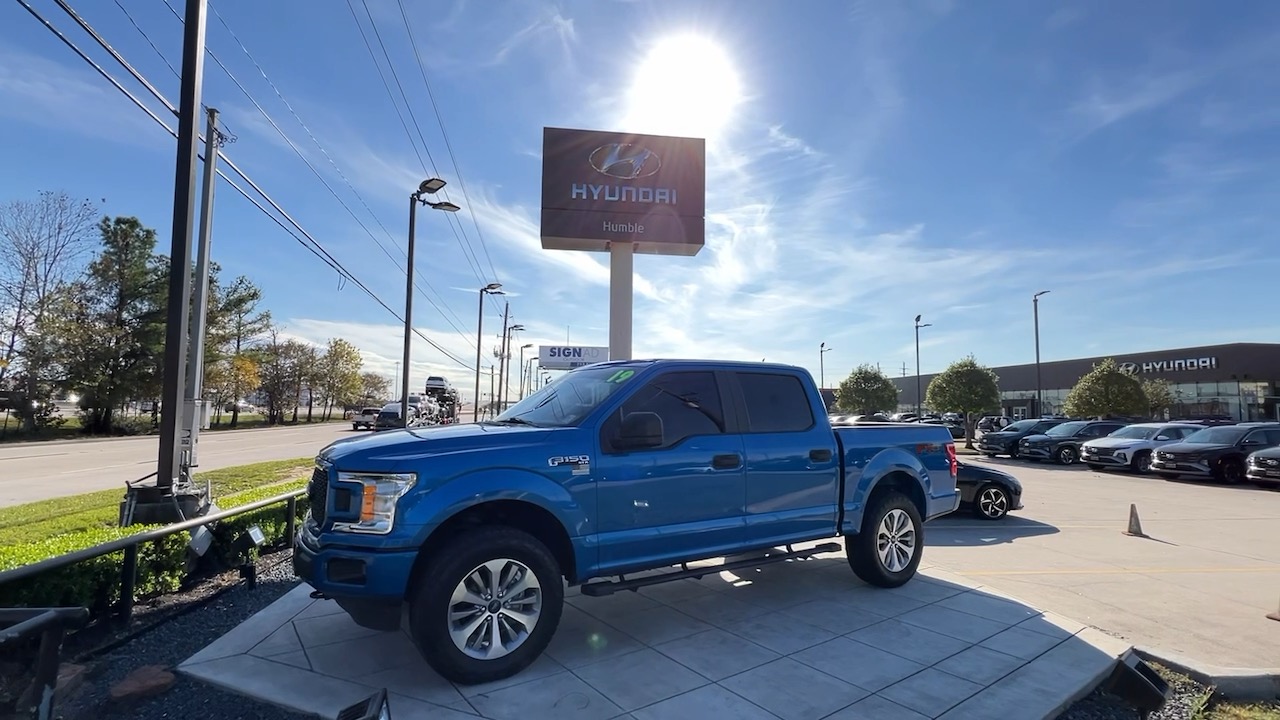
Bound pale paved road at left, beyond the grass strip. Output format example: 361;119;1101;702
0;423;352;507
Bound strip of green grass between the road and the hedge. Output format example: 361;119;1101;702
0;457;311;547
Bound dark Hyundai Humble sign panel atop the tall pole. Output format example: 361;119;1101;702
541;128;707;255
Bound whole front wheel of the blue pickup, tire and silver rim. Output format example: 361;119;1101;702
408;527;564;685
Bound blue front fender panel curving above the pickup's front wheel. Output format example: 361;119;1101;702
415;468;590;546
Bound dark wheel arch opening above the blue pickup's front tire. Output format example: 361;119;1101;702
410;500;577;584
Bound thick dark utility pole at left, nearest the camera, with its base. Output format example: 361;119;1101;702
138;0;206;524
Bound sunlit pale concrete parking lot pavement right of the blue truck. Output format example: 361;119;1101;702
925;457;1280;669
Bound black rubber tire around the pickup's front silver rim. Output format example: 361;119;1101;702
408;527;564;685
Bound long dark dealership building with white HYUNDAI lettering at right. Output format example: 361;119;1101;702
892;342;1280;421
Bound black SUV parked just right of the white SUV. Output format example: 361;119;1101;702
1151;423;1280;484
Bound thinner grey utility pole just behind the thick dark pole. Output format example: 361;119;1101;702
182;108;218;474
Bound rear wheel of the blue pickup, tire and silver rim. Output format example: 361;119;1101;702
845;491;924;588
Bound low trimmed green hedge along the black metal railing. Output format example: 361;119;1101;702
0;482;307;616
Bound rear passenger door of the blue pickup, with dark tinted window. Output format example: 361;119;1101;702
732;370;841;546
